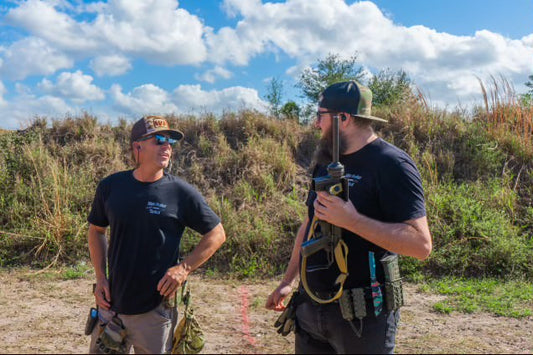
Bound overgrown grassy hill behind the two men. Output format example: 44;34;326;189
0;94;533;279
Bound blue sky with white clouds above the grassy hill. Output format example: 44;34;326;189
0;0;533;129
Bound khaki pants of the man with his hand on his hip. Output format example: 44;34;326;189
89;301;178;354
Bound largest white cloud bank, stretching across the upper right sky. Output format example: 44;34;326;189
206;0;533;103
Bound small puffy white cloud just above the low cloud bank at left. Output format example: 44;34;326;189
38;70;105;104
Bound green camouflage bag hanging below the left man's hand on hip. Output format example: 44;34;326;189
171;281;205;354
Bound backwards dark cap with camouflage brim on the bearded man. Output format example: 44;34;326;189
318;80;388;122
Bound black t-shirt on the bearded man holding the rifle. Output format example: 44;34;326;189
307;138;426;291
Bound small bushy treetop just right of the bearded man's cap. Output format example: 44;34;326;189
368;69;412;106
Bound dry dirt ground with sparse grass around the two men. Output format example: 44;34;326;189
0;269;533;354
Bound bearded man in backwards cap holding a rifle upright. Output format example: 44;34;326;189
266;81;432;354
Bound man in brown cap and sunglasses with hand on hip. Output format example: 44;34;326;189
88;116;226;353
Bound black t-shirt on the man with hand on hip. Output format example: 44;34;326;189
87;170;220;314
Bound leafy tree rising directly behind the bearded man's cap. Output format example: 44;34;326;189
296;53;363;103
